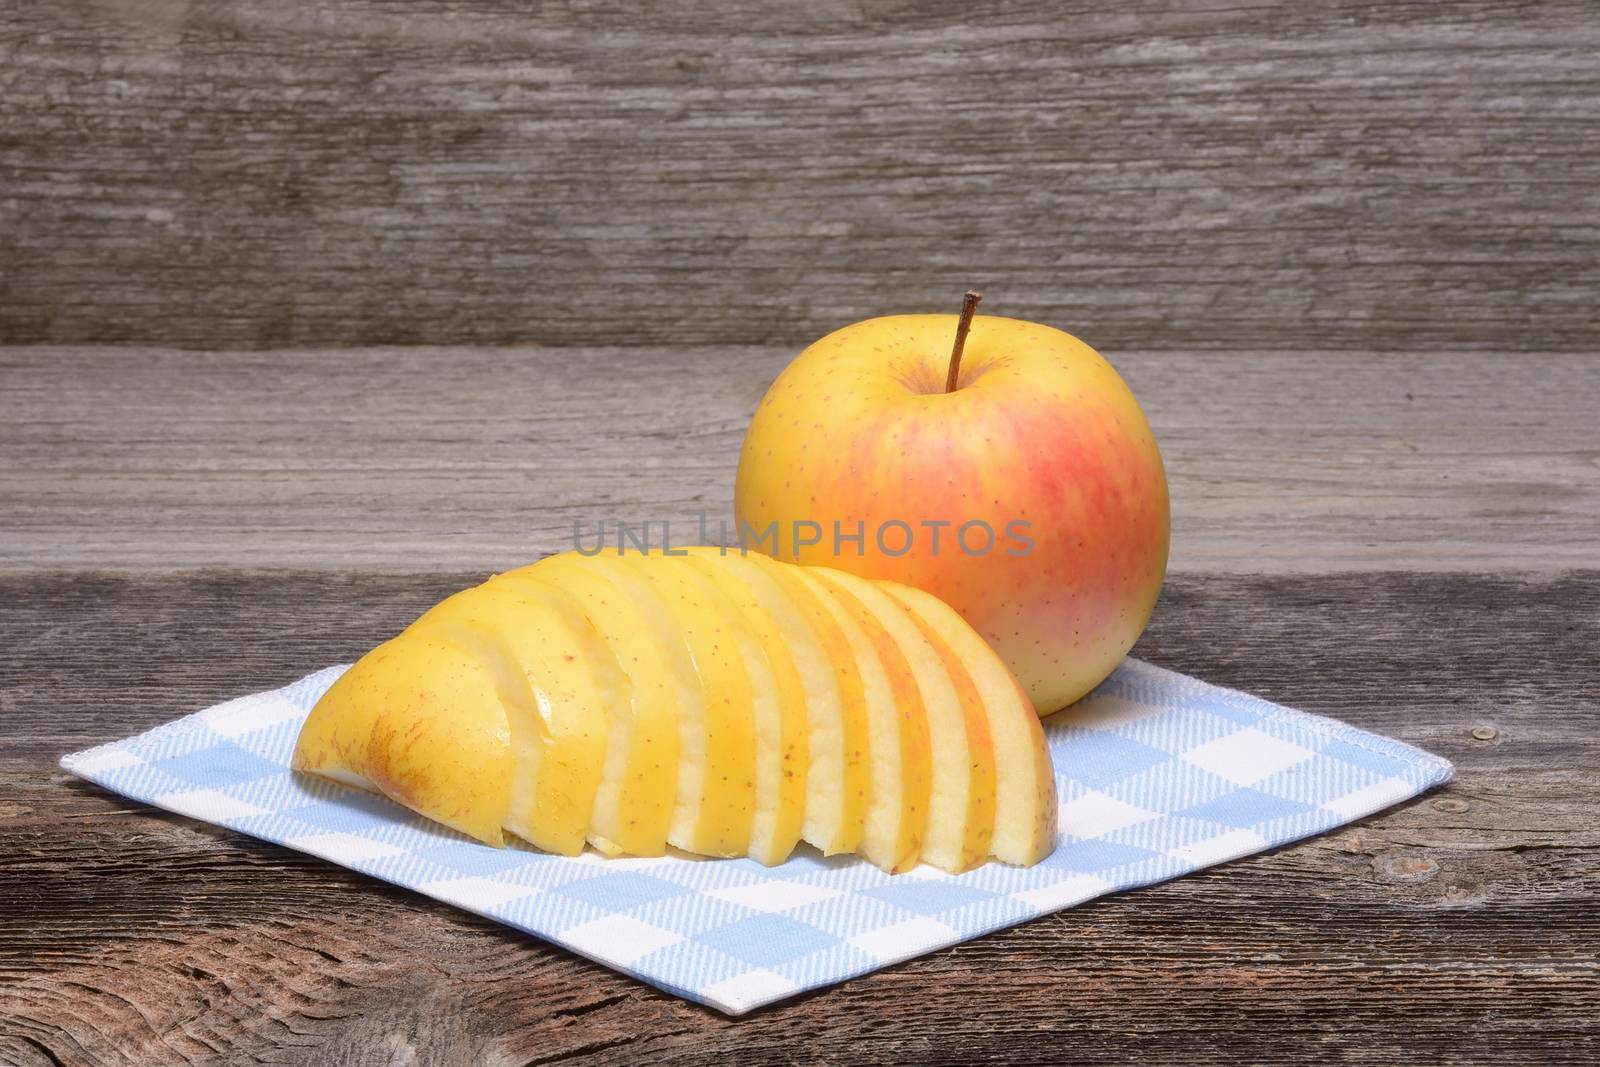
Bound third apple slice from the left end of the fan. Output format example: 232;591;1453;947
493;553;678;856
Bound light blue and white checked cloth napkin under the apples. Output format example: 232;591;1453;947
61;659;1451;1014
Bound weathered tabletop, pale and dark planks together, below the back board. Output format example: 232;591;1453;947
0;349;1600;1064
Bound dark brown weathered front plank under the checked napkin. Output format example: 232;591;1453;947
0;571;1600;1067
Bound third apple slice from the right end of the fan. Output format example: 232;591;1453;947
773;563;931;873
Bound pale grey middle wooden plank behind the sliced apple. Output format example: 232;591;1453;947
0;347;1600;573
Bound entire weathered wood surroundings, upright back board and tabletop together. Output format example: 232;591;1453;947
0;0;1600;1067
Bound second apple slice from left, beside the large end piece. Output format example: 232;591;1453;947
410;582;611;856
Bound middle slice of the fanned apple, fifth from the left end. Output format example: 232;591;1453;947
685;549;812;867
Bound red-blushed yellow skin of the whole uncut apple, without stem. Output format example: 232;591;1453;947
734;315;1170;715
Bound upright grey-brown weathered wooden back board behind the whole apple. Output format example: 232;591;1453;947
0;0;1600;352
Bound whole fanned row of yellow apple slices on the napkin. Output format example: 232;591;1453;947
294;549;1054;872
